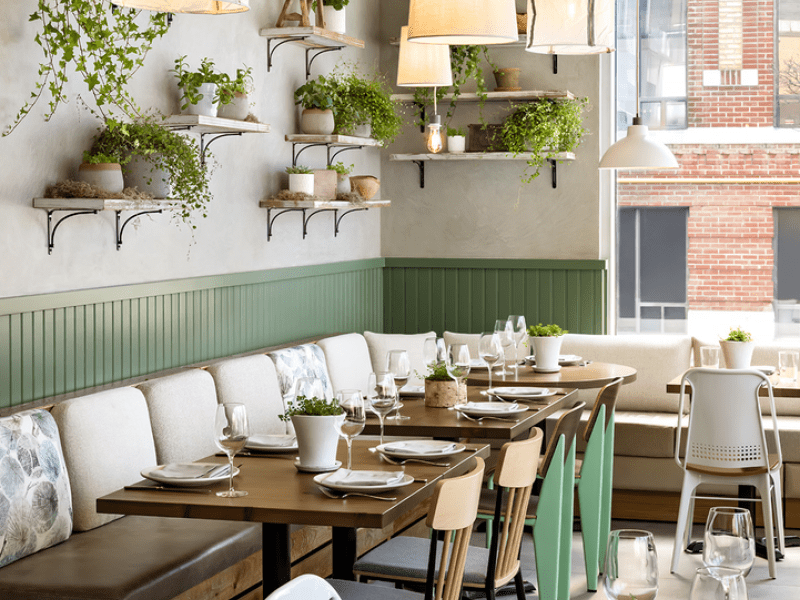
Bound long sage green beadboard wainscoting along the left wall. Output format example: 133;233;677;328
0;258;384;408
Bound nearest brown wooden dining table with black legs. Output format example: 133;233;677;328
97;439;489;597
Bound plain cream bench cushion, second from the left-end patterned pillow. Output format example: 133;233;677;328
138;369;218;464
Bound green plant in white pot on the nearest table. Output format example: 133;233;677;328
278;396;344;469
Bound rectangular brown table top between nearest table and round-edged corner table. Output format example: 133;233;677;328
364;386;577;440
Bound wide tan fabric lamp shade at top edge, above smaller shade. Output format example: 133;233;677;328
408;0;519;46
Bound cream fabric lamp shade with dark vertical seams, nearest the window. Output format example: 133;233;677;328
525;0;614;54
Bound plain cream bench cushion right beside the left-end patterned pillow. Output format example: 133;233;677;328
52;387;156;531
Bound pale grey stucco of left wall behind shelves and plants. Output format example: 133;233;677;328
0;0;381;297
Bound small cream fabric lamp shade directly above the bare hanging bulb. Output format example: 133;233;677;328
397;27;453;87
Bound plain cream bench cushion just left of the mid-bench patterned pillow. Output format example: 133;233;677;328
207;354;286;434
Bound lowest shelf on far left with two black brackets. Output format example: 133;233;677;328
33;198;181;254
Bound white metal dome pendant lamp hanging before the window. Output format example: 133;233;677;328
600;0;678;170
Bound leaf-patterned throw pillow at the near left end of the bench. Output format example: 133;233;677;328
0;410;72;567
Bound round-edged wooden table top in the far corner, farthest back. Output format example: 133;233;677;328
467;362;636;389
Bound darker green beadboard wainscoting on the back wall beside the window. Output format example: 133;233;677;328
383;258;607;334
